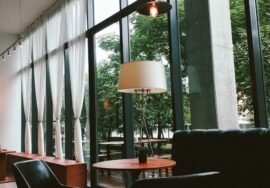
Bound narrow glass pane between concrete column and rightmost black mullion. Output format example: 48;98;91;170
230;0;254;128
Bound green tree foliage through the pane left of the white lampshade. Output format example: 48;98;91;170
97;35;123;140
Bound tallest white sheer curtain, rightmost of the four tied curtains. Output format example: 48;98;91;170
66;0;87;162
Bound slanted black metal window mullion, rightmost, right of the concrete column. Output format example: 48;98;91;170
244;0;268;128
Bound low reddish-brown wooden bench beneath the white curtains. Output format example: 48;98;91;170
7;153;87;188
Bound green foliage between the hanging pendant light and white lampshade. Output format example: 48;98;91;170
130;14;169;61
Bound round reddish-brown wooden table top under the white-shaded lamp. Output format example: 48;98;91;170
93;158;176;171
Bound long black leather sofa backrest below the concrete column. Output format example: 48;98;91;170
172;128;270;187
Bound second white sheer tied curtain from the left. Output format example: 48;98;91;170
33;23;46;156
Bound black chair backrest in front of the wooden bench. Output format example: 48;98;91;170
13;160;61;188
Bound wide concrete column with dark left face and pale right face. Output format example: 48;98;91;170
185;0;238;129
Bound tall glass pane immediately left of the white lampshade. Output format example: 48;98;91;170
95;23;124;184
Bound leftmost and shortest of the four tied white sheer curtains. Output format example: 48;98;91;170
21;38;32;153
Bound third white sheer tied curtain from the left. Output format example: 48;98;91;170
46;8;65;159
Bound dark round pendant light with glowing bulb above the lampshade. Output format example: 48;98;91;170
137;0;172;17
